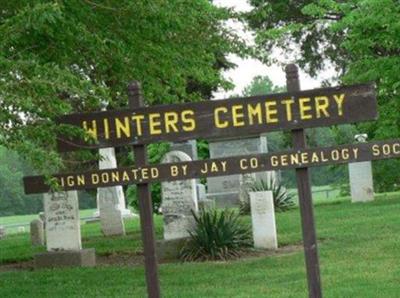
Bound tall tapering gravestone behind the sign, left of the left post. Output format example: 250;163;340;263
97;148;132;236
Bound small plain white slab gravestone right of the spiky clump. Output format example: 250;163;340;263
249;191;278;249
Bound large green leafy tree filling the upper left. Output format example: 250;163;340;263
0;0;245;173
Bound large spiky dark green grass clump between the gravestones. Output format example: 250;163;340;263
181;209;252;261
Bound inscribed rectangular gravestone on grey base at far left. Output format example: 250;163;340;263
44;191;82;251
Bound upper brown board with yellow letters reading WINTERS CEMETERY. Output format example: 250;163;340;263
58;84;377;152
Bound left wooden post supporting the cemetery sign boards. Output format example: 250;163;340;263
128;81;160;298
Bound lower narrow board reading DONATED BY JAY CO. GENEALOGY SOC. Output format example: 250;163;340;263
24;139;400;194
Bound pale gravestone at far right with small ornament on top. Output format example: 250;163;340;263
349;134;374;203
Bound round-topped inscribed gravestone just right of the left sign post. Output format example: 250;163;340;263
161;151;198;240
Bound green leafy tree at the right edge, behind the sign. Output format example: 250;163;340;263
246;0;400;190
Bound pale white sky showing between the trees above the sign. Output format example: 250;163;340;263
214;0;334;99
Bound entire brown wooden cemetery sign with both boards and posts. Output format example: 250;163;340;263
24;65;388;297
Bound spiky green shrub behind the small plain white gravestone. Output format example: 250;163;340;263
239;178;295;214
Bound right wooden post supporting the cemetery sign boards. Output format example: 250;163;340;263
285;64;322;298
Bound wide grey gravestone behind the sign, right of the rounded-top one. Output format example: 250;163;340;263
207;136;268;208
